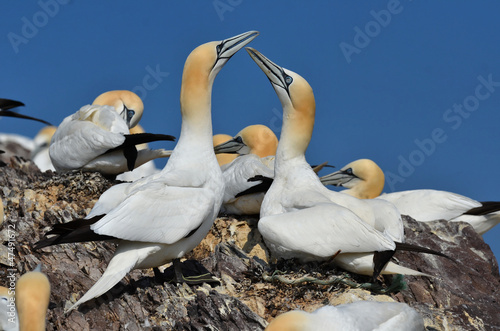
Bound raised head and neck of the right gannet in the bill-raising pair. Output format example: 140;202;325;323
246;47;316;160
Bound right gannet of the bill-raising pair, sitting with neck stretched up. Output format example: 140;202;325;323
247;47;446;279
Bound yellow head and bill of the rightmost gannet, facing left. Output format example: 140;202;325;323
321;159;385;199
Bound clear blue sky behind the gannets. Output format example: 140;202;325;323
0;0;500;268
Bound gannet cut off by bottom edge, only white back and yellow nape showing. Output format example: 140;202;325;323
265;301;425;331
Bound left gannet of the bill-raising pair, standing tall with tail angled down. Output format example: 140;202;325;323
36;31;259;310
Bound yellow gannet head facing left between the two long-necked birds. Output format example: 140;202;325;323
214;124;278;157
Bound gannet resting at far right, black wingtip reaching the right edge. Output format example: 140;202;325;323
321;159;500;234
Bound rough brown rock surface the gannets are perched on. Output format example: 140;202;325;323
0;154;500;330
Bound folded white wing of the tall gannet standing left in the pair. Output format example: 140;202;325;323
91;181;215;244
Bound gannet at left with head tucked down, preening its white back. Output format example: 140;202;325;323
49;91;174;175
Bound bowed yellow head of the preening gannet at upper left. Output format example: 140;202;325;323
92;90;144;128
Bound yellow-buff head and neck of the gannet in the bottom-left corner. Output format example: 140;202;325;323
15;266;50;331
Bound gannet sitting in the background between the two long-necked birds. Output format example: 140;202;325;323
214;124;278;215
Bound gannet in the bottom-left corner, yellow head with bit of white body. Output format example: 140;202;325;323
0;266;50;331
